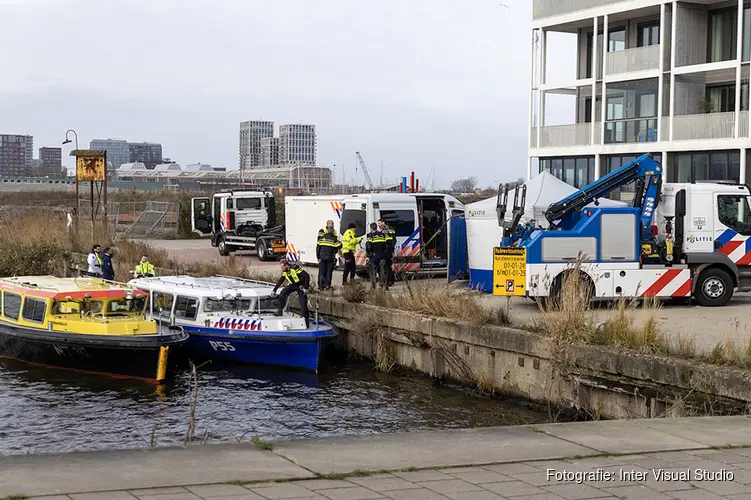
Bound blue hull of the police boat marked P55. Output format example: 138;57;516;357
178;327;336;372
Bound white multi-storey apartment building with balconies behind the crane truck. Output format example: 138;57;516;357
528;0;751;199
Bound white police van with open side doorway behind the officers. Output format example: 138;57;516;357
339;193;464;273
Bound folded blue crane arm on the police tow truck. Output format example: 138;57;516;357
545;154;662;239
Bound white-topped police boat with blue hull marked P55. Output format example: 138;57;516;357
129;276;336;373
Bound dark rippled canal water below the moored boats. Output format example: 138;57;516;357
0;360;547;455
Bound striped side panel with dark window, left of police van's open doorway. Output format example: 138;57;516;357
377;198;422;273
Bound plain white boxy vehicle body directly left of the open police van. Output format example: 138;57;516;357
284;195;345;264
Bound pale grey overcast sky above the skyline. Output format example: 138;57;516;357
0;0;576;187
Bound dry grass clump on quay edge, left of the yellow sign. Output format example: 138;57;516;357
366;281;509;325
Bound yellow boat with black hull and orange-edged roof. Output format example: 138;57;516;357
0;276;188;382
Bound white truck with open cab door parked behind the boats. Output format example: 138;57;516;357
191;191;284;260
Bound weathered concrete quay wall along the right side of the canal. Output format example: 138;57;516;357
311;295;751;418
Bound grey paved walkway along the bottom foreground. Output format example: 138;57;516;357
0;416;751;500
